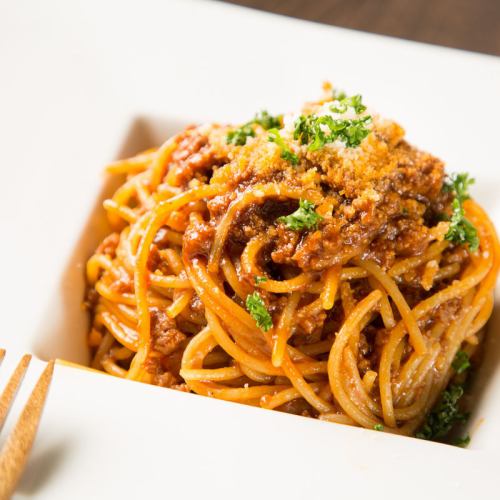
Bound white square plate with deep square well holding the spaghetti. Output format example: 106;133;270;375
0;0;500;500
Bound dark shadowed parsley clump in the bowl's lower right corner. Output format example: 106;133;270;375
415;384;469;440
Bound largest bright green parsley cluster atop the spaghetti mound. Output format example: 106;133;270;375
293;115;371;151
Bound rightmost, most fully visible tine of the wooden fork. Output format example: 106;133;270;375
0;361;54;500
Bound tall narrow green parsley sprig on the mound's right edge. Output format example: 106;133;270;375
443;174;479;252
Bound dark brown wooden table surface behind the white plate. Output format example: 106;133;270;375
222;0;500;55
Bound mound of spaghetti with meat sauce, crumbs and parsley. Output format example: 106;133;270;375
87;86;499;442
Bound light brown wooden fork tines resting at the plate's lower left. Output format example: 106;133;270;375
0;349;54;500
